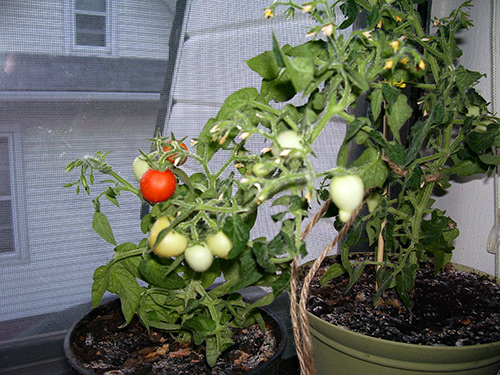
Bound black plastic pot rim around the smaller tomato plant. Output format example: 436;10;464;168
63;299;288;375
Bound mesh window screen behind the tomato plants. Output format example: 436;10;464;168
0;0;349;346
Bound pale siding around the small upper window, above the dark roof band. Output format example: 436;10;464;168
0;0;175;59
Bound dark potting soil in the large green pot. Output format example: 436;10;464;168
298;257;500;346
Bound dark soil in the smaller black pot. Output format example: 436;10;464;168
72;301;280;375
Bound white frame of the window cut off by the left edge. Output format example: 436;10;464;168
0;132;29;266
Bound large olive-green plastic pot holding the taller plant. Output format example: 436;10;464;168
300;265;500;375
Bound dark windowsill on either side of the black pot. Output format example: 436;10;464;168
0;289;298;375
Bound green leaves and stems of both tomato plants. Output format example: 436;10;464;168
66;0;500;365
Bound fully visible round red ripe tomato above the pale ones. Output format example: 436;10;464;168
139;169;177;203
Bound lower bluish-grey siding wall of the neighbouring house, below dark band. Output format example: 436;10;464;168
0;103;157;320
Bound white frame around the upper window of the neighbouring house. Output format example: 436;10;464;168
67;0;113;55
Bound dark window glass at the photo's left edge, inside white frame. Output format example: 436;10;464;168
0;135;15;254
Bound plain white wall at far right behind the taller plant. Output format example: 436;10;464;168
433;0;500;274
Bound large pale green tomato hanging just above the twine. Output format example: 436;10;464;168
330;175;365;212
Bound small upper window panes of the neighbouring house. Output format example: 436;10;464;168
73;0;109;48
